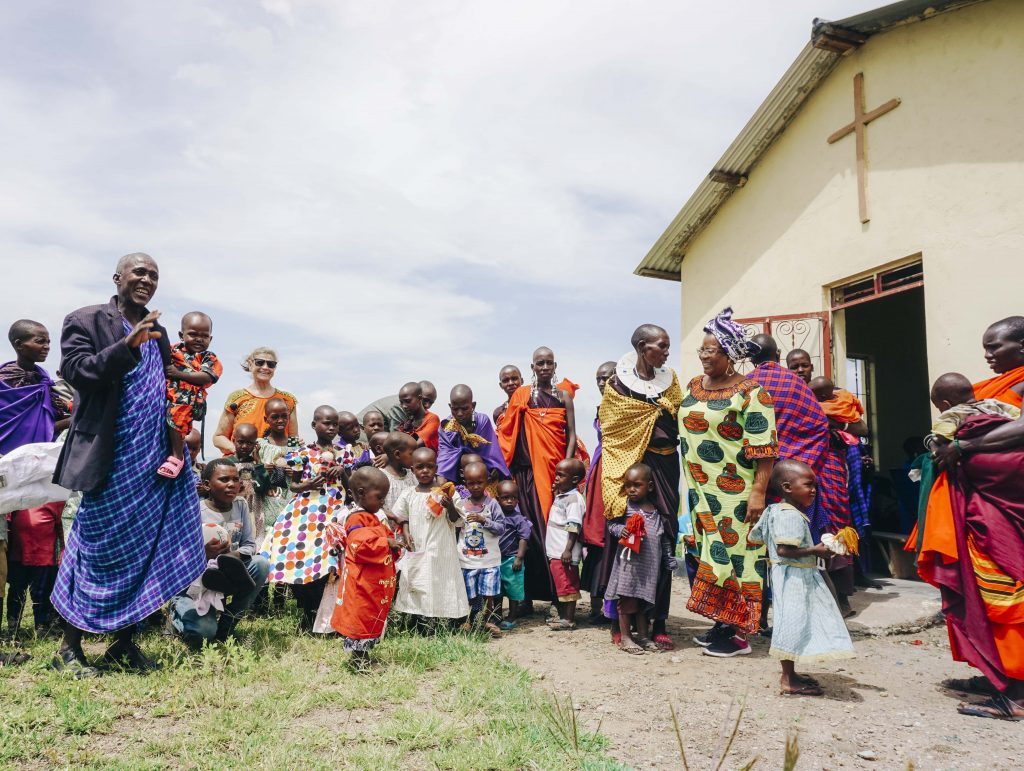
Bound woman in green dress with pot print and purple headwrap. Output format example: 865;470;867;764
679;308;778;658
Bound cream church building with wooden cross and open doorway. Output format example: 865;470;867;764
636;0;1024;470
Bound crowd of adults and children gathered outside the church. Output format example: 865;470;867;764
0;254;1024;717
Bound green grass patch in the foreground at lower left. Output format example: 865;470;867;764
0;615;620;770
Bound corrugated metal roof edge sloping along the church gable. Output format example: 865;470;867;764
634;0;984;281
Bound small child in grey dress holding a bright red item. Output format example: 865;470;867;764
604;463;676;655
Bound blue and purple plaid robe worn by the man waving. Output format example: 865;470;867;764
52;325;206;633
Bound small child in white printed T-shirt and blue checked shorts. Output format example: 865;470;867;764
446;463;505;636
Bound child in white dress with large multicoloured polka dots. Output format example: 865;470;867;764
262;404;346;632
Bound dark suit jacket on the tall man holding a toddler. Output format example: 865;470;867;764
53;296;171;492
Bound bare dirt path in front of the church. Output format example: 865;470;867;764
495;581;1024;771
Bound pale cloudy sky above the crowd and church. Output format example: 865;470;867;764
0;0;880;443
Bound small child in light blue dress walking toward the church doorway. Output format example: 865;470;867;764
748;461;854;696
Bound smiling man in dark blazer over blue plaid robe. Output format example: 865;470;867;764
52;253;206;678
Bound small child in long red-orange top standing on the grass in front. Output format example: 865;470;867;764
331;466;398;669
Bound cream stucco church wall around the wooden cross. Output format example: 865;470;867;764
677;0;1024;391
